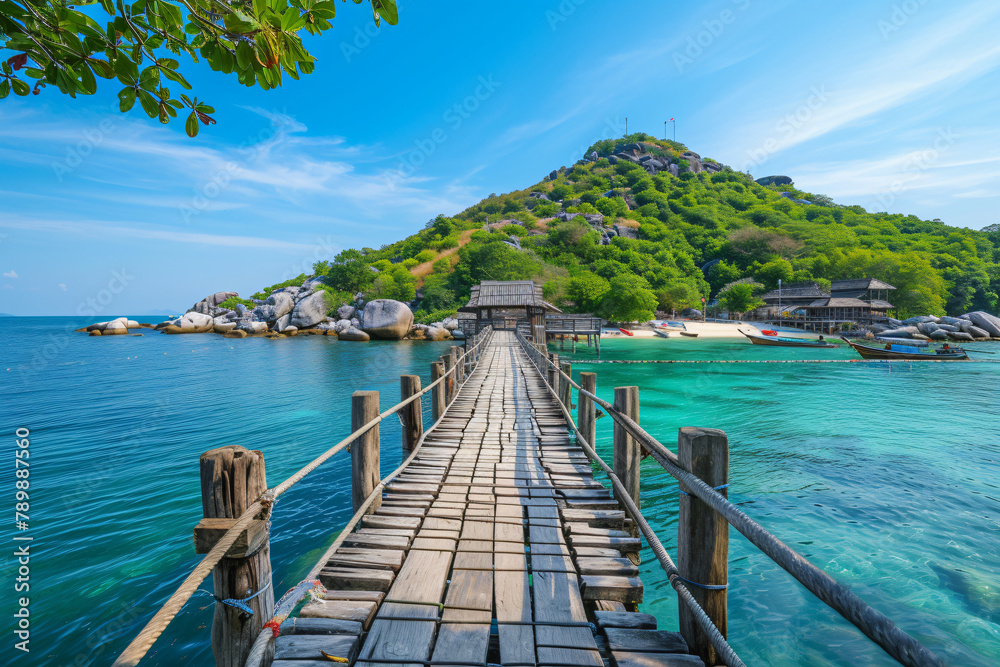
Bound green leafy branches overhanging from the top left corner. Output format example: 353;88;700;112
0;0;398;137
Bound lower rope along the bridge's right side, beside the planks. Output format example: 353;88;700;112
518;335;746;667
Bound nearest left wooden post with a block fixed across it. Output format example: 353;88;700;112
195;445;274;667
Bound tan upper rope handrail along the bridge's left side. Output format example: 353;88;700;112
112;329;492;667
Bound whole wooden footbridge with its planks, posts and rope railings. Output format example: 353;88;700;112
115;328;941;667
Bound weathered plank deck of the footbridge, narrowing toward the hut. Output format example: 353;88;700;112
273;331;703;667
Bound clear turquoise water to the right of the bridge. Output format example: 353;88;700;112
552;339;1000;667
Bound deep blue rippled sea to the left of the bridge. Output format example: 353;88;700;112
0;316;448;666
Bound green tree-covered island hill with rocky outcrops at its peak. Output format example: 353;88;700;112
261;134;1000;321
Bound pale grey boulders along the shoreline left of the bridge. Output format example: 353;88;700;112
77;278;465;342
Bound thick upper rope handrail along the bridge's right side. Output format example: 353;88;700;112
519;338;942;667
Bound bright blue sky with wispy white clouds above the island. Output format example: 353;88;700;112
0;0;1000;317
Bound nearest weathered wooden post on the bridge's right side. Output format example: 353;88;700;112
677;428;729;665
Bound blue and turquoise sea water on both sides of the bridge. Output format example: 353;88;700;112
0;317;1000;666
